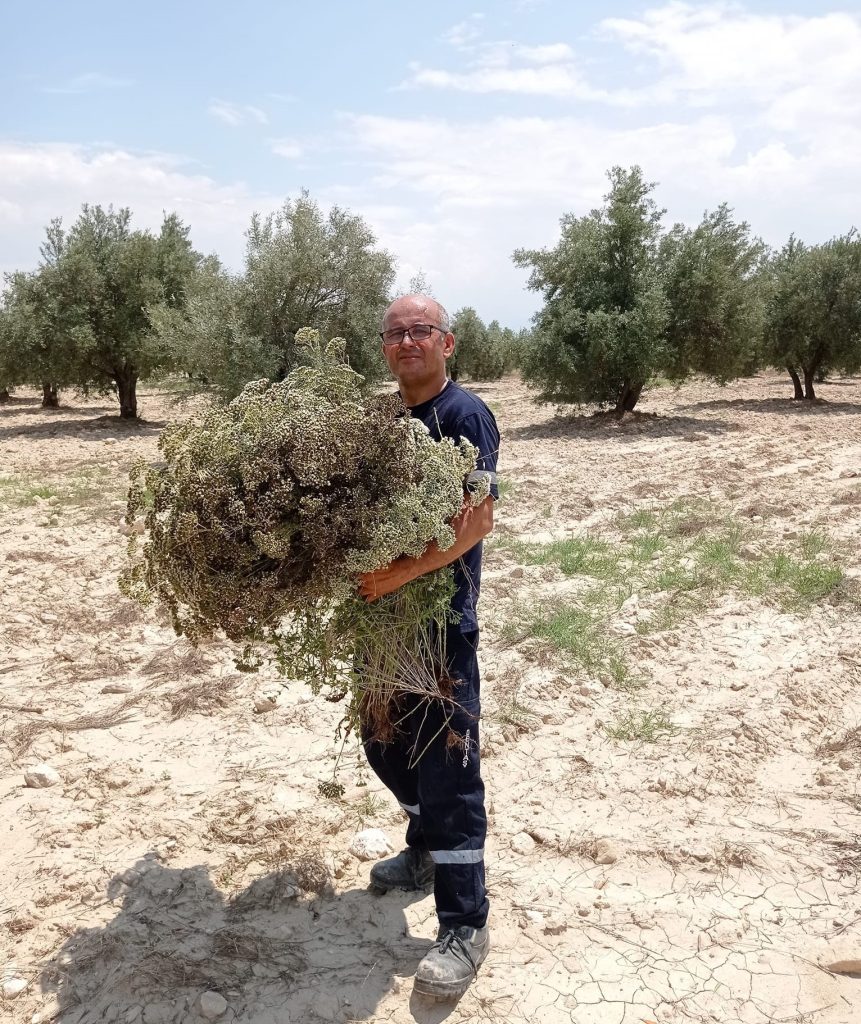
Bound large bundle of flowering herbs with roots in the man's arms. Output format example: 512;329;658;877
121;331;484;731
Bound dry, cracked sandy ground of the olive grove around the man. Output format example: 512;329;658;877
0;375;861;1024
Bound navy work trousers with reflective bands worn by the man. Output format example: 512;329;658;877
362;626;488;928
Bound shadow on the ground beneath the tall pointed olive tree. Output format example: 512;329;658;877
505;407;739;443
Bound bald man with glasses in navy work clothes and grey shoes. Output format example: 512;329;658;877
360;295;500;998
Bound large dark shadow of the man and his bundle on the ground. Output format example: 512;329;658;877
40;853;454;1024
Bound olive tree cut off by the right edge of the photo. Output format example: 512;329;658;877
764;230;861;398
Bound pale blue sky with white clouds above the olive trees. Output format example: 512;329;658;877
0;0;861;328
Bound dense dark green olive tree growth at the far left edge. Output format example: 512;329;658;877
0;205;198;418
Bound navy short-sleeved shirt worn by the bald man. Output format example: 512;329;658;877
410;380;500;633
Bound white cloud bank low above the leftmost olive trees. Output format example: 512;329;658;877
0;142;282;271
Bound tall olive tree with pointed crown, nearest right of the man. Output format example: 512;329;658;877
514;167;669;412
